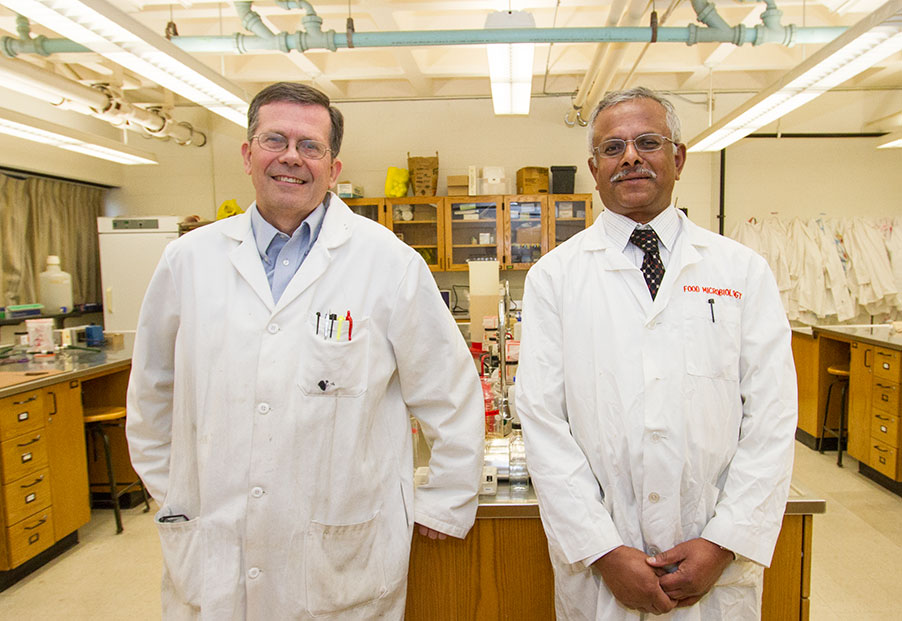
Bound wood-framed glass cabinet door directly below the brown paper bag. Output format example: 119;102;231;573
385;196;446;272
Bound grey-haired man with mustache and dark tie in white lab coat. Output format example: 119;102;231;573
517;88;797;621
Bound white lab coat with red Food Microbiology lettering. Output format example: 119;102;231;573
517;214;797;621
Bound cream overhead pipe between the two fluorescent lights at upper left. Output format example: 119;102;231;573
0;57;207;147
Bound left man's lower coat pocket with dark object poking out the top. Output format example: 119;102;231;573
155;509;204;607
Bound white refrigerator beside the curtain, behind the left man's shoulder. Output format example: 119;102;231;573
97;216;179;332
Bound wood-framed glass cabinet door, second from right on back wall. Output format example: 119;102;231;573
504;195;548;269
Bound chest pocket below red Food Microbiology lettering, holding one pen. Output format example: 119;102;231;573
683;298;741;380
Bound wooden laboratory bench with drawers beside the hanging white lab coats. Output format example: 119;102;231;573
792;325;902;495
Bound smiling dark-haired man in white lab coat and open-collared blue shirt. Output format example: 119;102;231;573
128;83;484;621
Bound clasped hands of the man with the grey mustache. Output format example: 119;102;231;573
592;538;733;615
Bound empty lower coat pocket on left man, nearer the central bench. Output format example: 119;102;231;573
304;513;388;617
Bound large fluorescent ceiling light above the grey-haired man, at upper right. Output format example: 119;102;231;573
689;0;902;152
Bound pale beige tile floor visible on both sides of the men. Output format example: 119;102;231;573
0;444;902;621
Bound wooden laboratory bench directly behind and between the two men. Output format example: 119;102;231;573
405;481;826;621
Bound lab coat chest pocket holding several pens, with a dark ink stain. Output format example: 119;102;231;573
297;318;369;397
